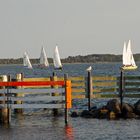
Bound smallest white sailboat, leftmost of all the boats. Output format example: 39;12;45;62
23;52;33;69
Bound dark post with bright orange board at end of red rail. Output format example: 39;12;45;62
64;74;72;125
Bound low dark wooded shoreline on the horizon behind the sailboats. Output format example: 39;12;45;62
0;54;140;65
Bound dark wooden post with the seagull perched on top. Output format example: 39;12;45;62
87;71;92;111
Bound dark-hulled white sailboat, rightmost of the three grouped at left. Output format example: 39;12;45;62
53;46;62;69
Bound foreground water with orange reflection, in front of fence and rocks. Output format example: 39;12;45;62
0;105;140;140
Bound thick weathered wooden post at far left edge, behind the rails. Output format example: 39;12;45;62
0;75;10;124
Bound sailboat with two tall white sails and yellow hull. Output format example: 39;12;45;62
122;40;137;70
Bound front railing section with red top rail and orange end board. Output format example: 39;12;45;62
0;75;71;123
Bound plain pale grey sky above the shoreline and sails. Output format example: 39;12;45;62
0;0;140;58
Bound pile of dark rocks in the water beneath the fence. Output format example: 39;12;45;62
71;99;140;119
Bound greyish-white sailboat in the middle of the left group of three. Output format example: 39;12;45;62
39;47;49;68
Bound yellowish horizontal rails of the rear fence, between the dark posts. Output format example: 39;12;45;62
23;76;140;98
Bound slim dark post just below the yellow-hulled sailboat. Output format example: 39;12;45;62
119;70;124;112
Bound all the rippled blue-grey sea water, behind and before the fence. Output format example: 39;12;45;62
0;63;140;140
